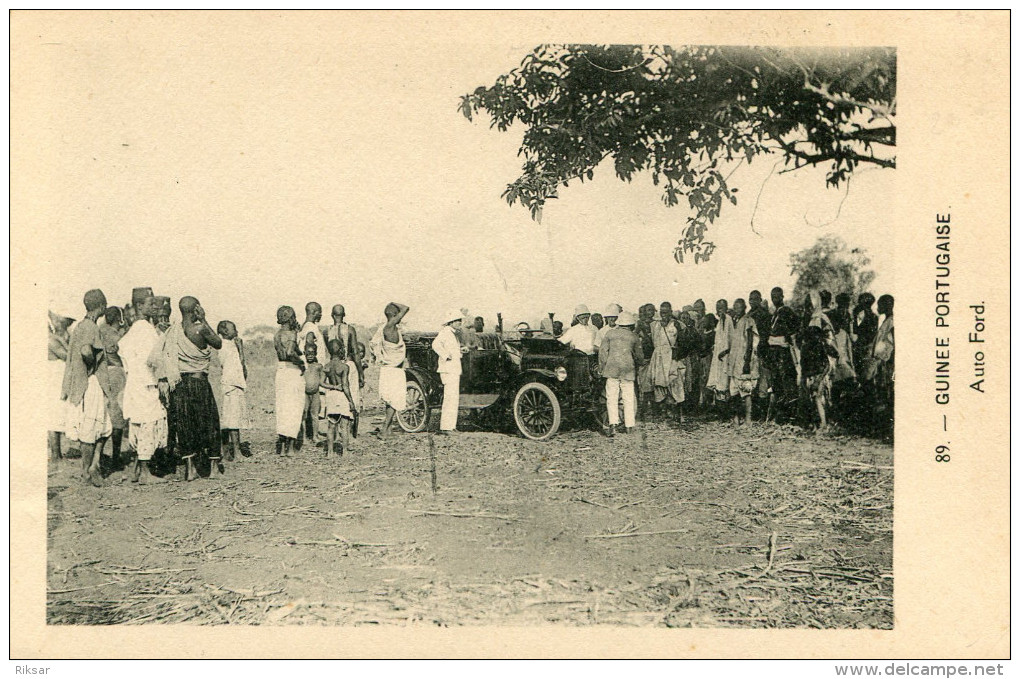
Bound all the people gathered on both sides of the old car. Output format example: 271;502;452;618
48;288;895;486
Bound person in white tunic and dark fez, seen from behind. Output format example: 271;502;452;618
120;288;166;483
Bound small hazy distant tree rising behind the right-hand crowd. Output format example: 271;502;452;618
789;236;875;304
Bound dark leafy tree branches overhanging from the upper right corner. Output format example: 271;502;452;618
460;45;897;262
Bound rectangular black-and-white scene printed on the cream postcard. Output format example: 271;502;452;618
37;31;898;630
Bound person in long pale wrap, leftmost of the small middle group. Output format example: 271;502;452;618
272;306;305;455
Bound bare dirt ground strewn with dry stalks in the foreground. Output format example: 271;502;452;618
47;362;893;629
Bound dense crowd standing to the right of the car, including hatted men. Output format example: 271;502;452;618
542;288;895;435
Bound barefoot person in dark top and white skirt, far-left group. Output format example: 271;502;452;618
60;290;113;486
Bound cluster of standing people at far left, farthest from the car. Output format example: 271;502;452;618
48;288;242;486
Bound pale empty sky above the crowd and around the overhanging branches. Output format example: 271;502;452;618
27;14;896;329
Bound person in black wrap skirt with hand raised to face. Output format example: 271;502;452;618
149;296;223;481
